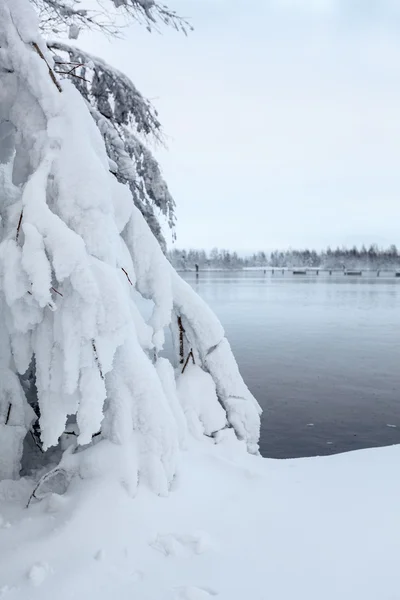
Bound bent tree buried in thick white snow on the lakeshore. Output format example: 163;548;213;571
0;0;260;494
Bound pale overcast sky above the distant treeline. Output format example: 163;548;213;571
82;0;400;251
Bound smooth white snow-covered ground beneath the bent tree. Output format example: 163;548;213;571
0;432;400;600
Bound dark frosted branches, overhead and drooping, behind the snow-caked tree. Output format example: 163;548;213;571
31;0;189;251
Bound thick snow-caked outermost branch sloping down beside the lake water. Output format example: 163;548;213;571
122;210;261;452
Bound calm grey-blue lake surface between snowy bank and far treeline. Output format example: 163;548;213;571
181;271;400;458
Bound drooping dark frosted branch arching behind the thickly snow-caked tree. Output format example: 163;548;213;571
48;41;175;251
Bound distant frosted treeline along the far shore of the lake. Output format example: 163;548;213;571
168;245;400;270
